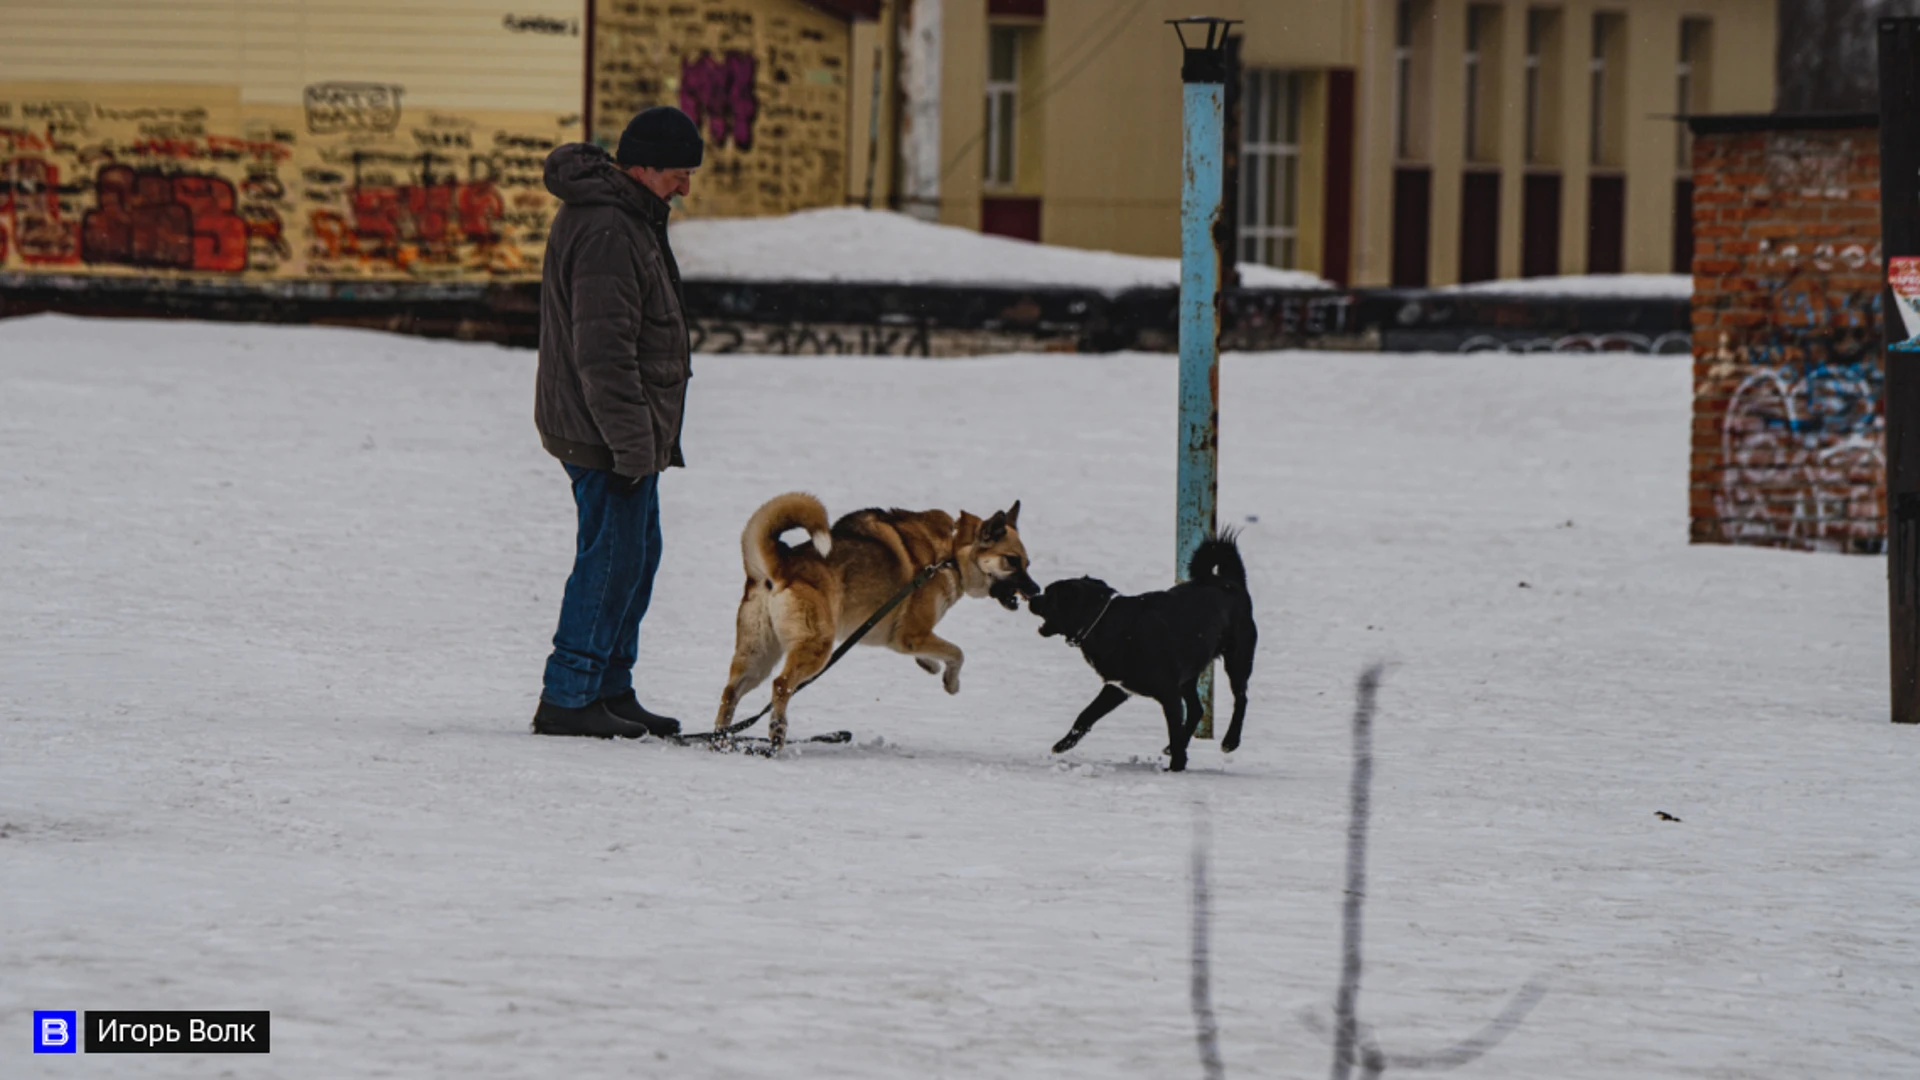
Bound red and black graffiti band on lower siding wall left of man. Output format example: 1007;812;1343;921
0;83;580;281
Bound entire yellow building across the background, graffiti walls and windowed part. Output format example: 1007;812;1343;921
0;0;1774;284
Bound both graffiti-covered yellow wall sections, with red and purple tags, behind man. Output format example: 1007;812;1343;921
0;0;851;281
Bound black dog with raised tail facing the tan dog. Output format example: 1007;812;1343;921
1027;532;1260;773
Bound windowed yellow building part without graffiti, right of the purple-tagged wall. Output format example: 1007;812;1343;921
849;0;1776;284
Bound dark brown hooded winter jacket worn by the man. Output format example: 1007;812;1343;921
534;142;693;477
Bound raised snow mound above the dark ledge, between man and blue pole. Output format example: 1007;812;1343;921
674;206;1332;292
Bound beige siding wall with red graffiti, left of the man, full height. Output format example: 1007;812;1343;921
0;0;584;281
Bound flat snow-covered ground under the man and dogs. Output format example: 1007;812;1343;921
0;317;1920;1080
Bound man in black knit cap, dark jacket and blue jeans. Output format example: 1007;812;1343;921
534;106;703;738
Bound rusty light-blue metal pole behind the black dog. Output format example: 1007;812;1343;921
1167;15;1238;738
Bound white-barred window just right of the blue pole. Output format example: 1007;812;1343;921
1240;69;1304;267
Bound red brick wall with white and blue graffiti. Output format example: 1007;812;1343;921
1690;117;1887;553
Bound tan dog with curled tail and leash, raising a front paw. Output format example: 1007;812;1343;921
714;492;1041;748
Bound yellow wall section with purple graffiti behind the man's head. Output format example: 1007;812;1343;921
591;0;851;217
